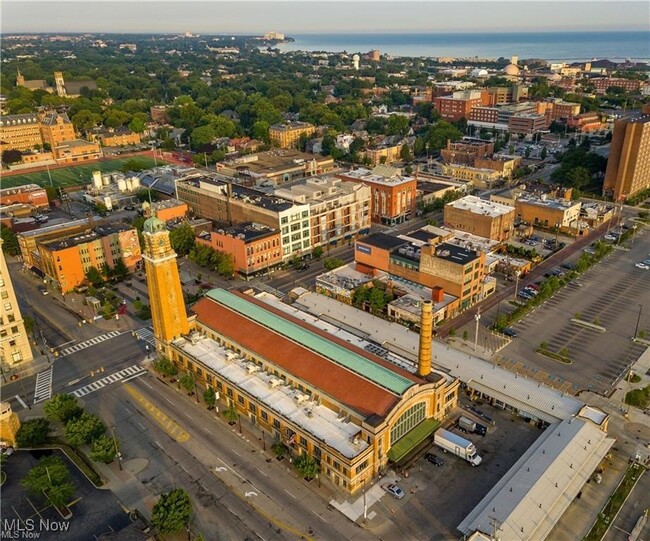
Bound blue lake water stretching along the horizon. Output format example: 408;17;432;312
279;32;650;61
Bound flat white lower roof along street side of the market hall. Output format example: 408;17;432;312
180;338;369;458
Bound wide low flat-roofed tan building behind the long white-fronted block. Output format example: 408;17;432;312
217;148;334;187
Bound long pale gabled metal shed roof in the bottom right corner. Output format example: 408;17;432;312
458;417;615;541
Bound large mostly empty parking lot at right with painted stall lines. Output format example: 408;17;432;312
496;226;650;395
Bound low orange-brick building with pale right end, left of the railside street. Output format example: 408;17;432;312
515;195;581;229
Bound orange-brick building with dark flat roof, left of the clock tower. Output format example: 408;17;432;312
36;224;142;293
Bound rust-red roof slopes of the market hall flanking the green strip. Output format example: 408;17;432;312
193;295;421;416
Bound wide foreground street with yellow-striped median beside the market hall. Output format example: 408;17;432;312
82;374;373;540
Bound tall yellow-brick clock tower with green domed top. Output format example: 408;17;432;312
142;217;189;351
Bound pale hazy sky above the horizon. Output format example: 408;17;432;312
0;0;650;35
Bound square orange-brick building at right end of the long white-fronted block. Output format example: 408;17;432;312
336;166;417;225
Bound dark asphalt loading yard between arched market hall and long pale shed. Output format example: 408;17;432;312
373;403;542;540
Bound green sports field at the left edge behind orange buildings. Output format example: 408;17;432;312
2;156;162;188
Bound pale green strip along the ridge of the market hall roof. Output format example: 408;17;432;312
206;289;415;395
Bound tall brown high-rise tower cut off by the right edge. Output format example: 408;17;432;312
603;115;650;201
